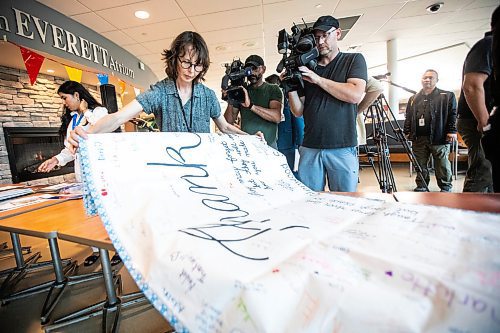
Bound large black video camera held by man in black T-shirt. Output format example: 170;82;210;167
276;22;319;94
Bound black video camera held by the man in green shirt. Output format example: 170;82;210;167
221;59;252;106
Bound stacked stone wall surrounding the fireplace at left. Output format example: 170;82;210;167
0;66;101;185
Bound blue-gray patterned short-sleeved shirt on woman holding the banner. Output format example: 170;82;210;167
136;78;221;133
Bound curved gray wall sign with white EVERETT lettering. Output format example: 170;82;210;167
0;0;157;86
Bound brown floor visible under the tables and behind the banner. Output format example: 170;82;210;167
0;164;464;333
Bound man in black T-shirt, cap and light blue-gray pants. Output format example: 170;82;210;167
288;16;367;192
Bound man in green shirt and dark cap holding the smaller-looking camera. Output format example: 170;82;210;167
223;54;283;149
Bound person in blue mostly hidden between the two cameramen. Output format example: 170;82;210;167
266;74;304;175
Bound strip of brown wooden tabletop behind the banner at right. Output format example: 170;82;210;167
393;192;500;213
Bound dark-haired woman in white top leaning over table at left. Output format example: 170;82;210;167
38;81;121;266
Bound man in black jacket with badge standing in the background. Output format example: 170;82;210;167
403;69;457;192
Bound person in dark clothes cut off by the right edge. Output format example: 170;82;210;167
457;8;498;193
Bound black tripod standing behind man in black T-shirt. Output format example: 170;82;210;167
365;94;429;193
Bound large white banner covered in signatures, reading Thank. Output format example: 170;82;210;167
80;133;500;333
